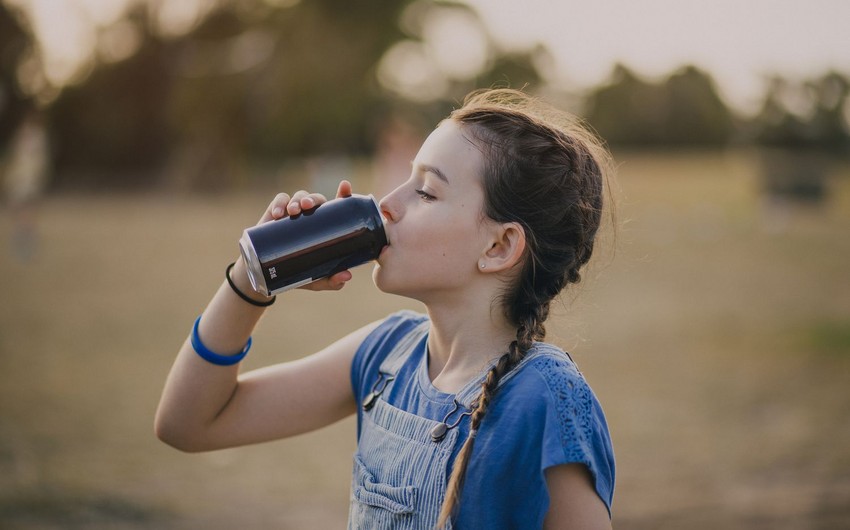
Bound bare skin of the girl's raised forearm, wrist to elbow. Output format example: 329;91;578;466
156;258;264;451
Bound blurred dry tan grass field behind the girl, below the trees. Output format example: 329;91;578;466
0;153;850;530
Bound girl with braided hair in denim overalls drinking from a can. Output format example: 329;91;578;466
156;90;614;529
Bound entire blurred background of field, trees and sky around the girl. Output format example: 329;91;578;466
0;0;850;530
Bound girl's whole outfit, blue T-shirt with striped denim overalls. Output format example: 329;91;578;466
349;312;615;530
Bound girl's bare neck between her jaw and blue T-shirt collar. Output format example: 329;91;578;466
420;305;516;393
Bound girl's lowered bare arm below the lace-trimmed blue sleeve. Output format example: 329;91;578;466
543;464;611;530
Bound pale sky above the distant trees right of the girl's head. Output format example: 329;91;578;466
465;0;850;109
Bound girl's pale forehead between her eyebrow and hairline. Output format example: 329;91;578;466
413;120;484;187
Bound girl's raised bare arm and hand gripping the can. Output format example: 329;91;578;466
155;182;376;451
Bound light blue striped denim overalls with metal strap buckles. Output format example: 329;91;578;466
348;321;556;530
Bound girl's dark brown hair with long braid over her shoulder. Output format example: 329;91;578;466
437;89;610;528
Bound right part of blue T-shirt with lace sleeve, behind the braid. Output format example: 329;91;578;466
461;343;615;527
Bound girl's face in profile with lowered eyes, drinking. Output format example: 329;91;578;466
372;120;492;303
